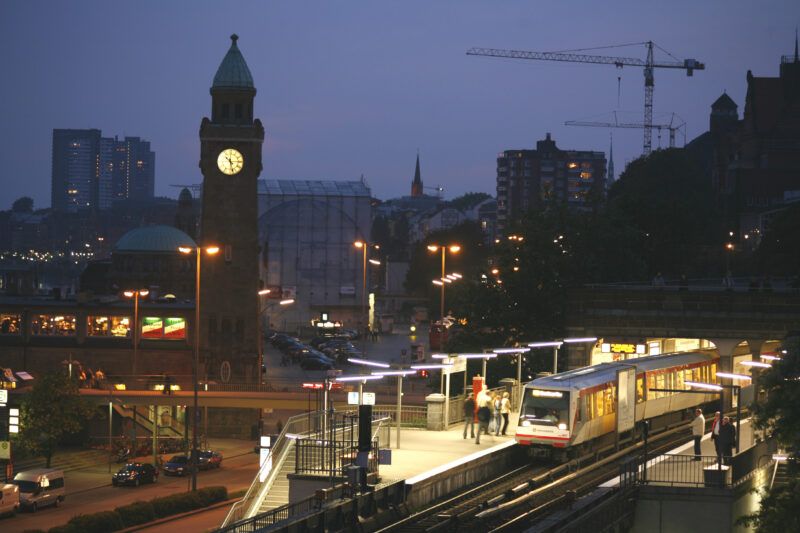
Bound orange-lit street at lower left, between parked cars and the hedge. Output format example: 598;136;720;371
0;446;258;533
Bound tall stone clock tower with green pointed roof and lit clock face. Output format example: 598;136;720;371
198;35;264;381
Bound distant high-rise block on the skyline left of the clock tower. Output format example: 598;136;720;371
51;129;155;212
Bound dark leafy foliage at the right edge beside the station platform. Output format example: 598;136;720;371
739;336;800;533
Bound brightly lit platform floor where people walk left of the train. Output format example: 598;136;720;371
380;413;517;484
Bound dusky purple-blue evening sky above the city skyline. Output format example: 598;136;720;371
0;0;800;209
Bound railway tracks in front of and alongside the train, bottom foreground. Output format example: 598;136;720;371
380;424;688;533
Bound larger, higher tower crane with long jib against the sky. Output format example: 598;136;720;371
467;41;706;155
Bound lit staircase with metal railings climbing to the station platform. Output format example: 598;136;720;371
222;411;325;527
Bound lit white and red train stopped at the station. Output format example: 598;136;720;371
515;352;719;459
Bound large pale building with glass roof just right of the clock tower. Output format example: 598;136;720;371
258;180;372;330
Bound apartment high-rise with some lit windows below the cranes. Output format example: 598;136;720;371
497;133;606;232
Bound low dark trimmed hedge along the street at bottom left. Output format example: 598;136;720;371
47;487;228;533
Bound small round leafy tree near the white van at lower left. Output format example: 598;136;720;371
18;372;94;468
